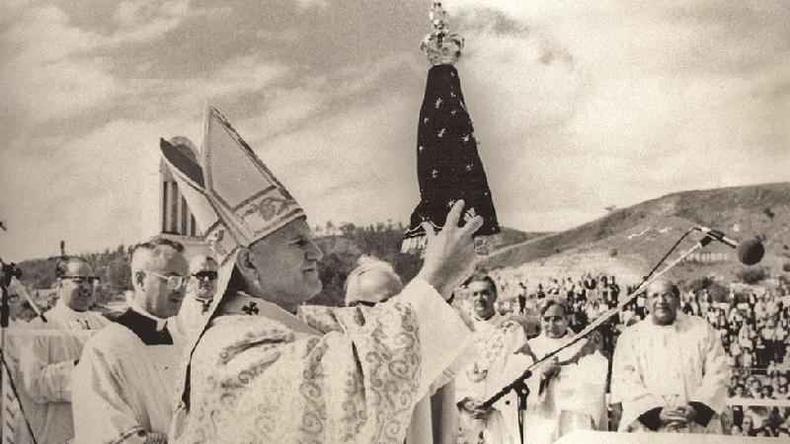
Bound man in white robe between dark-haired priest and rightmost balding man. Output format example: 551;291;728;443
524;299;608;444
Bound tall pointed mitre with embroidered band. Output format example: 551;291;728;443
161;106;305;264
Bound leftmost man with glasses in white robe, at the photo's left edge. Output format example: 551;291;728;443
14;257;110;444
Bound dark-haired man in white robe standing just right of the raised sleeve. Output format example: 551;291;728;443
455;274;532;444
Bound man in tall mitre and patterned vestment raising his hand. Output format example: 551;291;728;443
161;108;482;444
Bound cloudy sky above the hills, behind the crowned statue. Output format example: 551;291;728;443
0;0;790;260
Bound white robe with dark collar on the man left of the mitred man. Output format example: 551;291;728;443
73;308;184;444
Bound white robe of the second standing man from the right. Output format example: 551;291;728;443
524;330;609;444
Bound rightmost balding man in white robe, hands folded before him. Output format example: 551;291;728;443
612;280;729;433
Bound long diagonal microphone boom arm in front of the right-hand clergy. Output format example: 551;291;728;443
481;227;714;412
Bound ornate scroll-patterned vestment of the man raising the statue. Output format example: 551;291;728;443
170;280;469;444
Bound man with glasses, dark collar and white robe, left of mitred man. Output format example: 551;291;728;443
73;238;188;443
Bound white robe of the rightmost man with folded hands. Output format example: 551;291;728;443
612;312;730;432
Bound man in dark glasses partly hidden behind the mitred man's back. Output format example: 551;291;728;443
175;254;219;339
